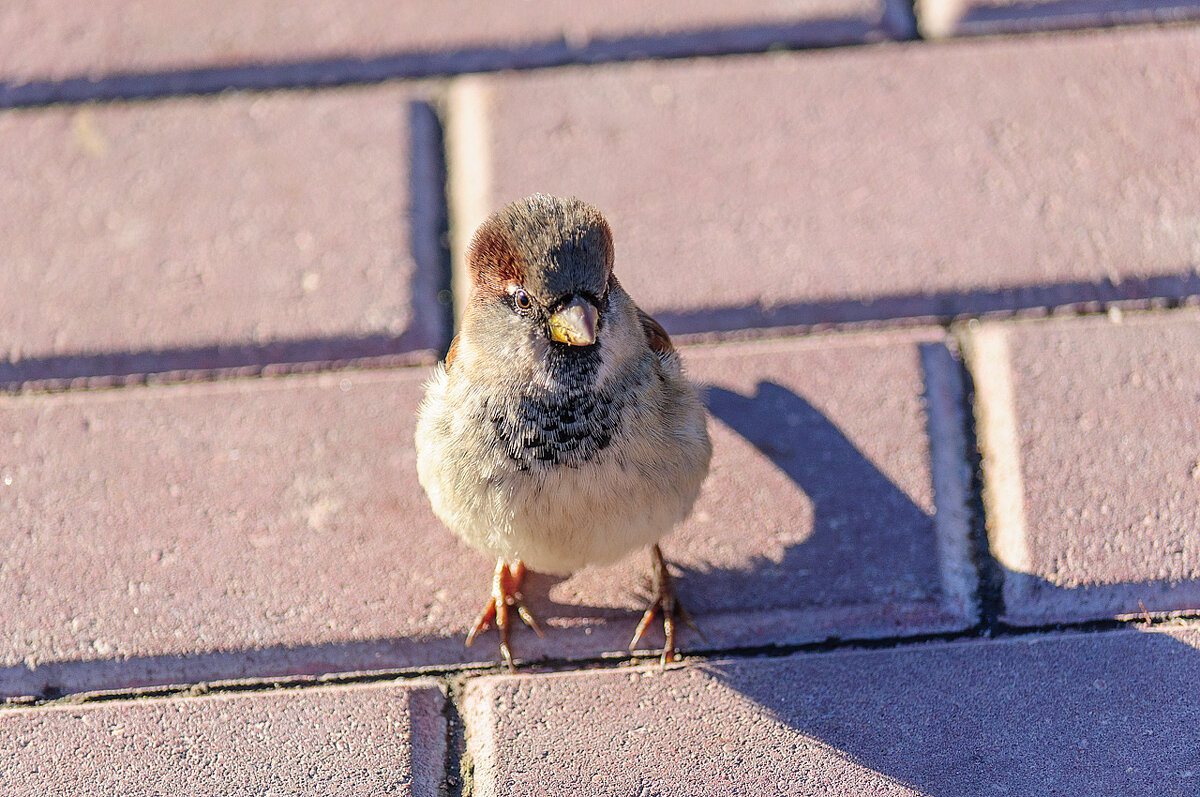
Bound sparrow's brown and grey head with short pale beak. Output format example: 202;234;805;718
463;194;613;367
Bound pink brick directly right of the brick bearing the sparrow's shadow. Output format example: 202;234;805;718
970;310;1200;624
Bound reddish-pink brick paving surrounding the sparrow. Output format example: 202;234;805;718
0;0;1200;795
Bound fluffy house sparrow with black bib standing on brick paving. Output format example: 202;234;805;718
416;194;712;669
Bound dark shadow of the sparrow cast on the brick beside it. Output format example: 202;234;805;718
696;382;940;612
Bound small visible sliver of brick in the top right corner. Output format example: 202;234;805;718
914;0;1200;38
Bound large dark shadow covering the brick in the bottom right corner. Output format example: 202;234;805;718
701;631;1200;797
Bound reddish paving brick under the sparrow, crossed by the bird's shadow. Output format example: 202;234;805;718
0;331;974;695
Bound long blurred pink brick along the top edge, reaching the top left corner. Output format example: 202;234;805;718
0;0;899;82
